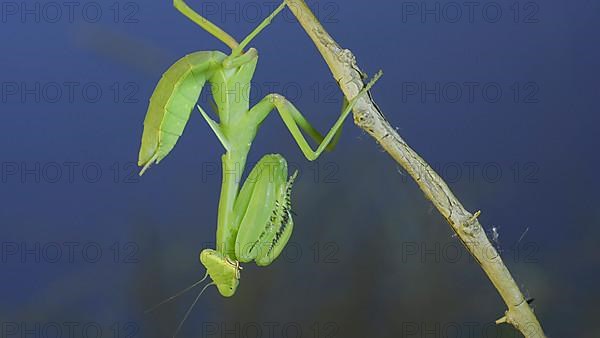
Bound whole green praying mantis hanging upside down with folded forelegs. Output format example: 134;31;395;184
138;0;381;334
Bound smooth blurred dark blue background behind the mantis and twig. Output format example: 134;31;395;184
0;0;600;337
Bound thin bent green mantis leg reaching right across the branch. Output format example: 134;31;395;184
248;72;382;161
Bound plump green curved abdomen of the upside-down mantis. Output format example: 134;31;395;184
138;51;226;174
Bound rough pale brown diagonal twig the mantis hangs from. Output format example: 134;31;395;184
285;0;545;338
